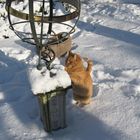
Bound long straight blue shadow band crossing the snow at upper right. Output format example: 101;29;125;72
75;21;140;46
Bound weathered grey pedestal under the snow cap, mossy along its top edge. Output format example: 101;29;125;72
37;89;66;132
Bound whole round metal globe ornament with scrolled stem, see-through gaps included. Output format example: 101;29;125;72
6;0;80;68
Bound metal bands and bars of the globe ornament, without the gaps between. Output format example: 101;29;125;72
6;0;81;69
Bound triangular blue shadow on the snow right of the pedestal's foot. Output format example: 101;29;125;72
43;90;130;140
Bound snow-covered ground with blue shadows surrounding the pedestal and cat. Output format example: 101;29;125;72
0;0;140;140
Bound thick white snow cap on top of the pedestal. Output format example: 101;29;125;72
27;60;71;95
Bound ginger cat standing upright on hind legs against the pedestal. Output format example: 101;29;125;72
65;52;93;106
